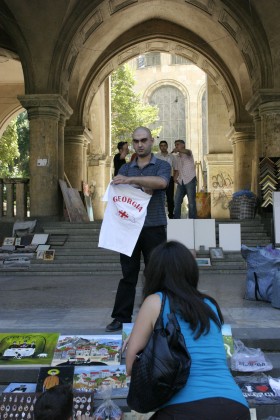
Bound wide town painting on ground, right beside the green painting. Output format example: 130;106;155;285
52;334;122;366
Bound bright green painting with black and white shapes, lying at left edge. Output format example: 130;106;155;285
0;332;59;366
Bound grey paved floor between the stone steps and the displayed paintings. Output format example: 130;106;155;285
0;272;280;334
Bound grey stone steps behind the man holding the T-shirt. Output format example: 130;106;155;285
0;218;272;276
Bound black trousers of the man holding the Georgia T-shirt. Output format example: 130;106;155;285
112;226;166;323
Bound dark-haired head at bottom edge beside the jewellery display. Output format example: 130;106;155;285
34;385;73;420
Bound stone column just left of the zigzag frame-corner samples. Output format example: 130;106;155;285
227;123;255;191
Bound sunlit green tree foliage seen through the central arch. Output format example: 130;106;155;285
111;64;161;153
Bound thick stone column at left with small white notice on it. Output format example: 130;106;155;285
18;94;72;217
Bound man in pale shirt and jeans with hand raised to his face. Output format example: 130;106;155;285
172;140;196;219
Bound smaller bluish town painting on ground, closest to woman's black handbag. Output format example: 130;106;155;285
73;365;130;399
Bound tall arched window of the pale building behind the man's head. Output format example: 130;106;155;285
149;85;186;151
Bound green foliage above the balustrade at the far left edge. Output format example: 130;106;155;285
0;111;29;178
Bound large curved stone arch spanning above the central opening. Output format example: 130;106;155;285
48;0;272;123
